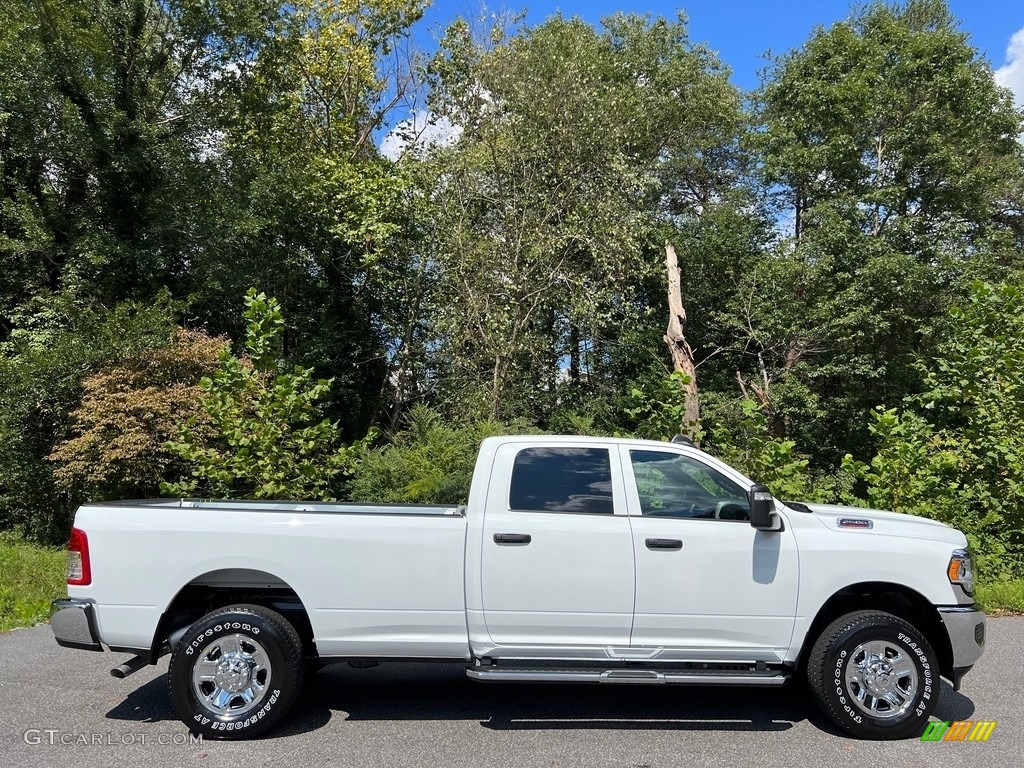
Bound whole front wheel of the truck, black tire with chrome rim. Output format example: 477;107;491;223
807;610;939;739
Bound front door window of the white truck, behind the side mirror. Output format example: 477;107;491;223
630;451;751;521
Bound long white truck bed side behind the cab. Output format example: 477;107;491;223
69;499;469;658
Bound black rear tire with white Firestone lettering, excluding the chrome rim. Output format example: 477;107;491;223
168;610;299;738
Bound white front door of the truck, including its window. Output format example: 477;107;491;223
620;446;799;662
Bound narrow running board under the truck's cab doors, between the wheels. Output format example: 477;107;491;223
466;667;791;686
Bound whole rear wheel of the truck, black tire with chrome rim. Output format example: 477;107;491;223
167;605;304;739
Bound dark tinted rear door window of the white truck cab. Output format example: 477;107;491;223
509;447;612;515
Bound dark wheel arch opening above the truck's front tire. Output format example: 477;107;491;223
797;582;953;679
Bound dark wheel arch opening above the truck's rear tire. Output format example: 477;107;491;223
150;568;317;664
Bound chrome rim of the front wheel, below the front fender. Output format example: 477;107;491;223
846;640;920;720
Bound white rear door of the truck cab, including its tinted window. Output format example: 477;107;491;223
470;439;634;656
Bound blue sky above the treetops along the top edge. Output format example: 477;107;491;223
413;0;1024;97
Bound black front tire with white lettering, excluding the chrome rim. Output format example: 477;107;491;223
818;616;939;738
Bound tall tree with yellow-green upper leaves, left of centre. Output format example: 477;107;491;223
180;0;423;438
